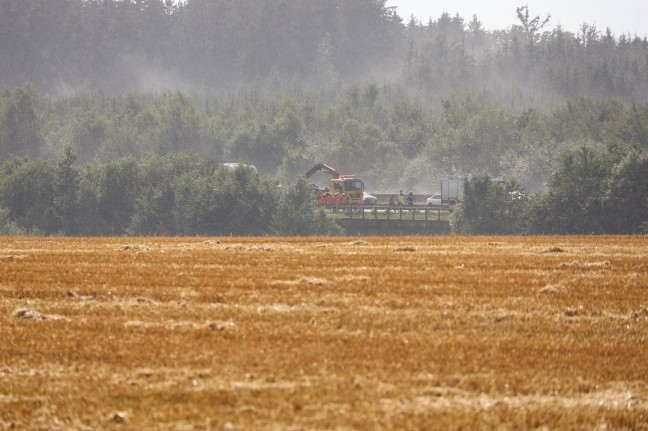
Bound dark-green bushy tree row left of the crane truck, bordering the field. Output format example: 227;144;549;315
0;151;342;236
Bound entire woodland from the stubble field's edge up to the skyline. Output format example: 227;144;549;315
0;0;648;235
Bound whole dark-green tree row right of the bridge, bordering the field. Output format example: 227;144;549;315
452;147;648;235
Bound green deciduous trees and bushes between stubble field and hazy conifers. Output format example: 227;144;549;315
0;91;648;235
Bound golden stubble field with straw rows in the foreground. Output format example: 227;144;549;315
0;236;648;430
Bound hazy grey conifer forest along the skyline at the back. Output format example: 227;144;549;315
0;0;648;109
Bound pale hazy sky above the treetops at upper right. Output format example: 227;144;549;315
387;0;648;37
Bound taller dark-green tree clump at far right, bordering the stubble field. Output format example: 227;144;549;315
529;147;648;234
